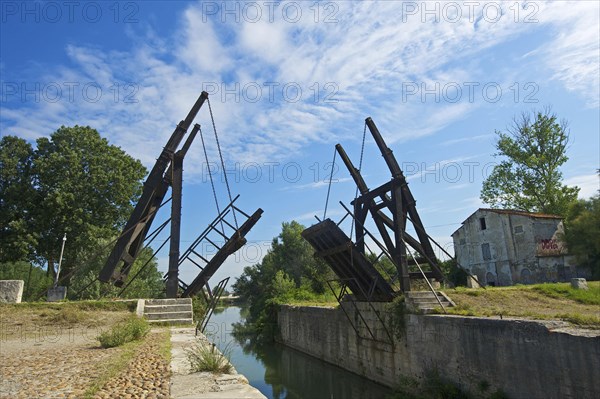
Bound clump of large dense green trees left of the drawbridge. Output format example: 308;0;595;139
0;126;146;285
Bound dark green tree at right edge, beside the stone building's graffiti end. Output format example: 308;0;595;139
564;195;600;279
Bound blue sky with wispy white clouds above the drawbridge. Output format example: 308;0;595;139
0;1;600;286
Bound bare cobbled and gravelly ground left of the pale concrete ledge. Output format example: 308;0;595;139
0;328;170;399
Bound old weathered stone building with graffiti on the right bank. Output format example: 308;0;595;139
452;208;586;286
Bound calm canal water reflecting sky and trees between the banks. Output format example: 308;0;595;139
206;307;391;399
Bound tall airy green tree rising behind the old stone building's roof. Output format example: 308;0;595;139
481;108;579;216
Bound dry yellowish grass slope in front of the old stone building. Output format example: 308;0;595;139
444;281;600;329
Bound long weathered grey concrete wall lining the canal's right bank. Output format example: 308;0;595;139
278;303;600;399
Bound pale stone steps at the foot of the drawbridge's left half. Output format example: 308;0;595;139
143;298;194;325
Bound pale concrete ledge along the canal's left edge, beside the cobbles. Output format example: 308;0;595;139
171;327;266;399
